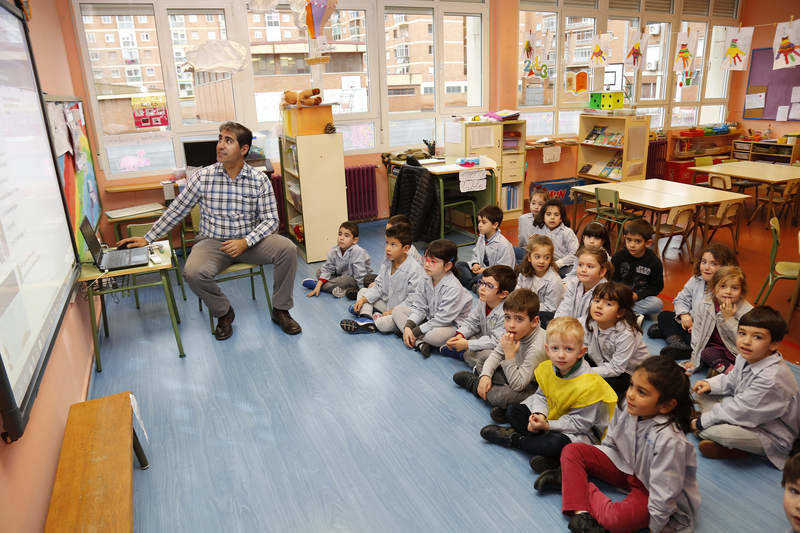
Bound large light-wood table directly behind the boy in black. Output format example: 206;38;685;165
571;179;749;255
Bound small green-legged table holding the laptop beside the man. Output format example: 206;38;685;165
78;241;186;372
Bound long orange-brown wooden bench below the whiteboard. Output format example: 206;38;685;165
45;392;149;533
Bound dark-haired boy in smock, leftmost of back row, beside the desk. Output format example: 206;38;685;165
456;205;516;290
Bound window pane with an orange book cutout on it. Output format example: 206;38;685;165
559;17;595;104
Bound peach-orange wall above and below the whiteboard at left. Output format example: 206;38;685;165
0;0;92;533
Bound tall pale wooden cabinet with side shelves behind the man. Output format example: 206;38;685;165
279;133;347;263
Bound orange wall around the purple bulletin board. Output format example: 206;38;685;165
728;0;800;137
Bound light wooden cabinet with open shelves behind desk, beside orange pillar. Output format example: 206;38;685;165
445;120;525;220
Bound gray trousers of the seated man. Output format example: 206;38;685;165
183;234;297;317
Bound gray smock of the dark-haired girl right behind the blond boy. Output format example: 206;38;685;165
580;317;650;378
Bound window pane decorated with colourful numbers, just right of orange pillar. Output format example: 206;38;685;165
517;11;558;107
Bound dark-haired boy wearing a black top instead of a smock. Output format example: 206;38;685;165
611;219;664;316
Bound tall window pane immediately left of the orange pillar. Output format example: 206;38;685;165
444;15;483;107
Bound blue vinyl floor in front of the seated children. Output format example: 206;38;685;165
91;222;788;533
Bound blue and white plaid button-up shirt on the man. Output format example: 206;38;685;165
144;163;279;246
